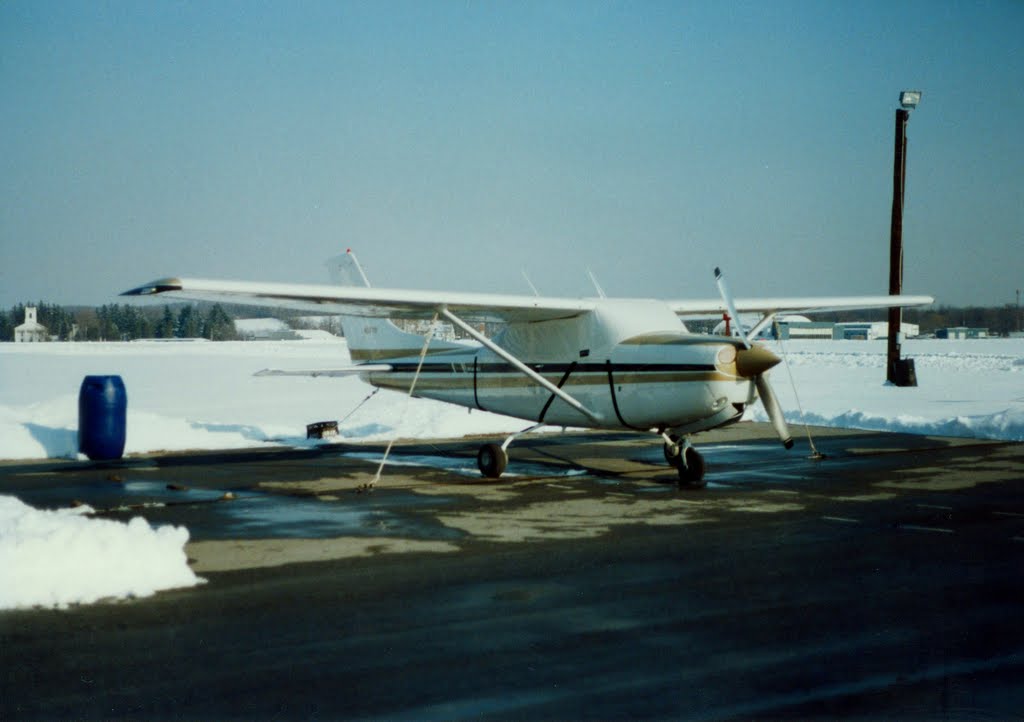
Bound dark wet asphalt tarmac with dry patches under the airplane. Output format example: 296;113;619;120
0;424;1024;720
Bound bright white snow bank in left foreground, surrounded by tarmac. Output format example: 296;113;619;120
0;496;202;609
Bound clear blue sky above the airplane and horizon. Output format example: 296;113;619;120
0;0;1024;307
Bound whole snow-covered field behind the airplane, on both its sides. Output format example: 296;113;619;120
0;337;1024;459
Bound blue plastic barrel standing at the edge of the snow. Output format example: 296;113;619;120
78;376;128;461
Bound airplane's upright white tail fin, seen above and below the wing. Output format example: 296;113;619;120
327;249;462;362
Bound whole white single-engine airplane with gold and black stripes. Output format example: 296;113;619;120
122;251;933;486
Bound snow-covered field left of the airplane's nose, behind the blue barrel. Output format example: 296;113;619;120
0;336;522;459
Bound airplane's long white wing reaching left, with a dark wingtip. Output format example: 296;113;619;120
121;279;597;323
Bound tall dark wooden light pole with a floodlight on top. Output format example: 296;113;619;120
886;90;921;386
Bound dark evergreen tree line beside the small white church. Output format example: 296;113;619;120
0;301;238;341
